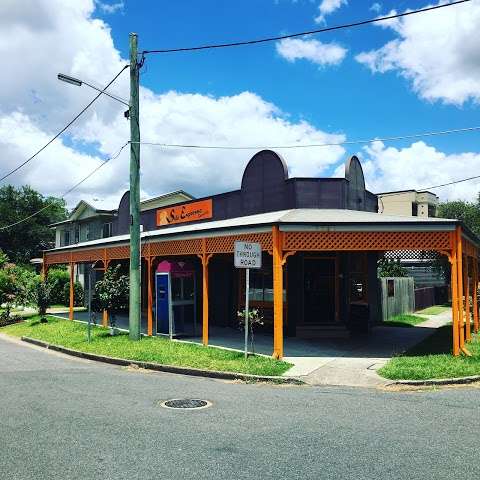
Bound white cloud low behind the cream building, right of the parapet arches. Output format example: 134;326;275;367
359;141;480;200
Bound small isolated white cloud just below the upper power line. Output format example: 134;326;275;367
276;38;347;67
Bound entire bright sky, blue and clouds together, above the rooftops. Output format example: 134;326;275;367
0;0;480;206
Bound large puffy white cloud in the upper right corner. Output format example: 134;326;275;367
356;1;480;105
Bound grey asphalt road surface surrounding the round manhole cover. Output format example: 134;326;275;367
0;339;480;480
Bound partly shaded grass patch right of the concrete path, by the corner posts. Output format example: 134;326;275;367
378;325;480;380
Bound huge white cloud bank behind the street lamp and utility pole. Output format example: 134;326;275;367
0;0;344;206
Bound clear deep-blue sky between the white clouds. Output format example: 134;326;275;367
99;0;479;161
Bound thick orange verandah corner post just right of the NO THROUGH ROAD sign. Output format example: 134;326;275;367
272;226;283;359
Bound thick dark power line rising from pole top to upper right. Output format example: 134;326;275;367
140;0;470;56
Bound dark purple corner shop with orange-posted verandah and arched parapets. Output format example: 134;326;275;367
44;150;478;358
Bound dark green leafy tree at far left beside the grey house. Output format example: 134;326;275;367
0;185;67;264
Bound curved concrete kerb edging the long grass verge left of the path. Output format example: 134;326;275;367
21;337;305;385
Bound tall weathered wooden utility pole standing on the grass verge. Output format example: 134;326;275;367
128;33;142;340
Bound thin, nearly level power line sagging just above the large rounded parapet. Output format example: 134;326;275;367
132;126;480;150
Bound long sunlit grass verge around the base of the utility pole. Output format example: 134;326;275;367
0;316;292;376
